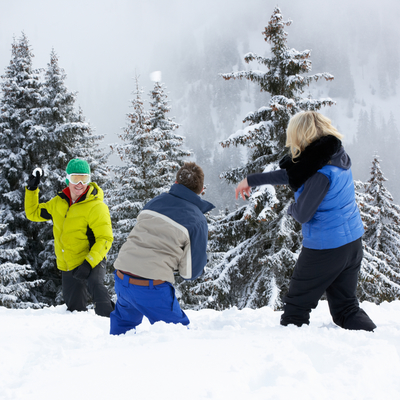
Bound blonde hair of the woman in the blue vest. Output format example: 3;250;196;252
286;111;343;159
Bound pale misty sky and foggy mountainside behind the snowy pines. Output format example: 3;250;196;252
0;0;400;208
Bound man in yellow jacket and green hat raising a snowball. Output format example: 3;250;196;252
25;158;114;317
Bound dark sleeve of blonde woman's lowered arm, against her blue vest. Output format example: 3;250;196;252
288;172;330;224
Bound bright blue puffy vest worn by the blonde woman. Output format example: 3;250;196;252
295;165;364;250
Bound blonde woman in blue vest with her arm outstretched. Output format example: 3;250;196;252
236;111;376;331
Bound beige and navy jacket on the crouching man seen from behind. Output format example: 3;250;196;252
114;184;214;283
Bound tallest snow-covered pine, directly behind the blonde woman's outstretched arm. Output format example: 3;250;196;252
181;8;333;309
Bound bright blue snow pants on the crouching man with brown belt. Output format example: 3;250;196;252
110;272;190;335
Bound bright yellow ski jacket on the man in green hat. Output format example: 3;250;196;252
25;182;113;271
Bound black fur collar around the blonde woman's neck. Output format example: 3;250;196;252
279;135;342;191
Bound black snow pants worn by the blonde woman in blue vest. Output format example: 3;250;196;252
281;238;376;331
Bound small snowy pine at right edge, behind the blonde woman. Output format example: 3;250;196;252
357;155;400;304
